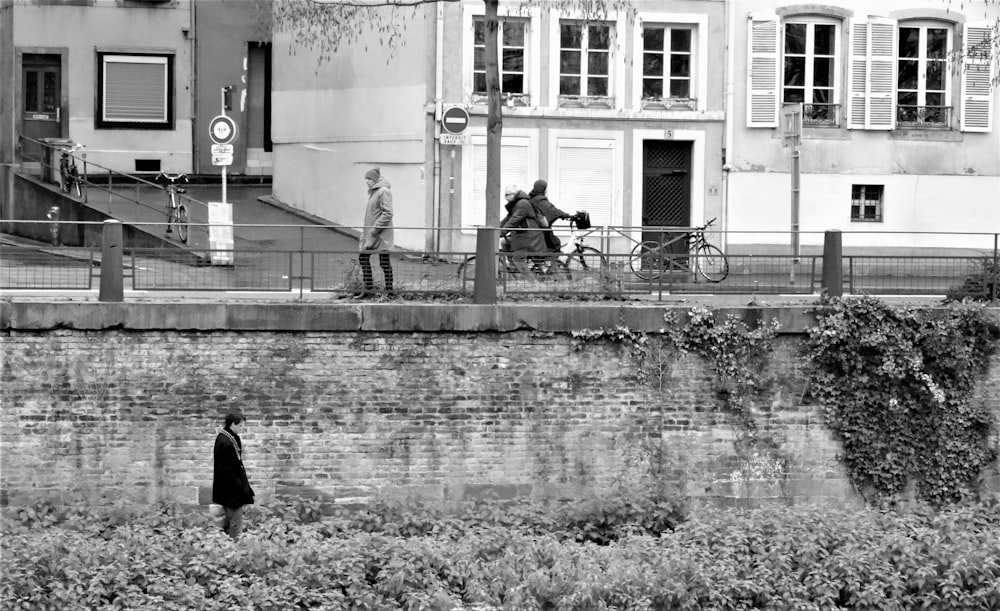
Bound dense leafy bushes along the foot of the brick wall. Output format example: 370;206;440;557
0;501;1000;610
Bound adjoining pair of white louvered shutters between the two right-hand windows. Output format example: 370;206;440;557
847;18;898;130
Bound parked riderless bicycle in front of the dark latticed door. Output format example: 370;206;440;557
629;219;729;283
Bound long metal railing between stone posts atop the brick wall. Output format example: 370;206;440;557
0;221;1000;303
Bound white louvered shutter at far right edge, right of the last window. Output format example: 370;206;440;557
961;23;994;132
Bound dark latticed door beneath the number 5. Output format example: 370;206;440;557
642;140;691;255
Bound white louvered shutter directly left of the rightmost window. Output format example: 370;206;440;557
865;18;899;130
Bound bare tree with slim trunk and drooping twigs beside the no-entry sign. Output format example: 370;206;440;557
262;0;630;227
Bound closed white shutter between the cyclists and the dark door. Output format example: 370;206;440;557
552;138;608;225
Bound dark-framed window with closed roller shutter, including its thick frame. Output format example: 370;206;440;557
96;53;173;129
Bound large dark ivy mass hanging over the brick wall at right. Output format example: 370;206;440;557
806;297;1000;505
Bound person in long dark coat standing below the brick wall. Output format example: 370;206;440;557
212;413;254;541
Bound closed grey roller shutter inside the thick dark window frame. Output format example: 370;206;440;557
103;55;167;123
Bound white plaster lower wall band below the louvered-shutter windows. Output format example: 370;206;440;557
728;172;1000;249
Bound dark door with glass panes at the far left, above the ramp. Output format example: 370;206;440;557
21;53;63;166
